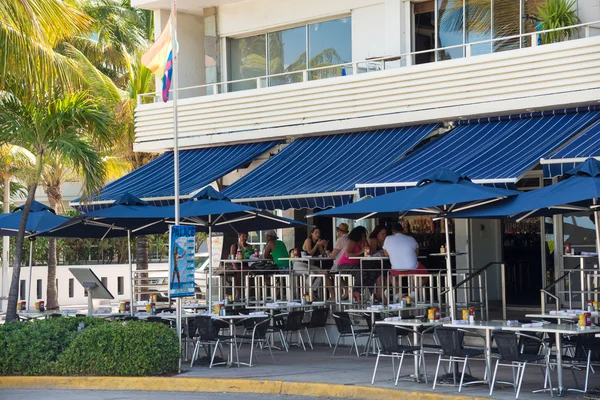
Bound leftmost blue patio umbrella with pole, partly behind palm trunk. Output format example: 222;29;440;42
0;200;69;308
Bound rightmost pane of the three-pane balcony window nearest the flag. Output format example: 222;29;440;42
308;17;352;79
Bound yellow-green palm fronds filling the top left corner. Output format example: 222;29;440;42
0;0;91;98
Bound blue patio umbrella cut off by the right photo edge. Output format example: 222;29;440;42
451;158;600;276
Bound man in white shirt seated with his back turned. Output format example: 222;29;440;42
383;223;419;274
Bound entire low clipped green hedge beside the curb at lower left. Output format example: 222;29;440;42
0;317;178;376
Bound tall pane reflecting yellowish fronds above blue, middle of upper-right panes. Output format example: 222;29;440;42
465;0;493;56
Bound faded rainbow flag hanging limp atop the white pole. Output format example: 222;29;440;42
142;17;177;102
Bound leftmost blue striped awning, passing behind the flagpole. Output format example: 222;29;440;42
71;141;280;211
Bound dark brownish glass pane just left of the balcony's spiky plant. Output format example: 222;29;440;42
493;0;521;52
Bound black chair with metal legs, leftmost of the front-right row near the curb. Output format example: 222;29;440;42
371;323;427;386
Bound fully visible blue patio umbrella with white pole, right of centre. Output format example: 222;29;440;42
314;168;518;319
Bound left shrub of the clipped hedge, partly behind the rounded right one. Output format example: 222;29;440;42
0;317;106;375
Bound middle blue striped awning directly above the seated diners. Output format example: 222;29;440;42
223;124;437;210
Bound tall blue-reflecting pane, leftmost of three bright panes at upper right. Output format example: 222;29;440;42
437;0;464;60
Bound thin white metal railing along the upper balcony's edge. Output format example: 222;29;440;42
138;21;600;104
